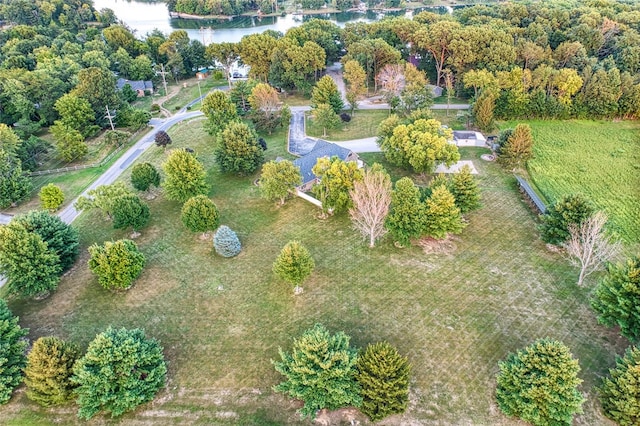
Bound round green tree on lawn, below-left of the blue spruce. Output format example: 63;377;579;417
89;240;145;290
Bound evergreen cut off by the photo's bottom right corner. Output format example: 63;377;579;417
600;347;640;426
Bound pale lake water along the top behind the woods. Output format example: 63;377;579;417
93;0;446;45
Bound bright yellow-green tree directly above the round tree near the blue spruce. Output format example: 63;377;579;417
162;149;209;203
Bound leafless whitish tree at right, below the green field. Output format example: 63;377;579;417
564;212;620;285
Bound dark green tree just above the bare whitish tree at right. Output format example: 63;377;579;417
540;194;595;245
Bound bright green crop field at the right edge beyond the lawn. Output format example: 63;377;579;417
502;120;640;243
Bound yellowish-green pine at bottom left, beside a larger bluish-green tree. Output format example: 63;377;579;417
24;337;80;407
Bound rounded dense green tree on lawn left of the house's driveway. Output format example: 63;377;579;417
215;120;264;174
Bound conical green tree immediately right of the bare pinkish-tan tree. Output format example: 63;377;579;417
386;177;426;245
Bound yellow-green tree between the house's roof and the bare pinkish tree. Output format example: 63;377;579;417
311;157;364;213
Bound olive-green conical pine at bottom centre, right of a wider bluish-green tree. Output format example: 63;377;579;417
356;342;411;422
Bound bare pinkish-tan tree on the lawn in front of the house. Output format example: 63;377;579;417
349;163;392;247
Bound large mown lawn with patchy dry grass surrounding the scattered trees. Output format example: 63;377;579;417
0;121;626;425
